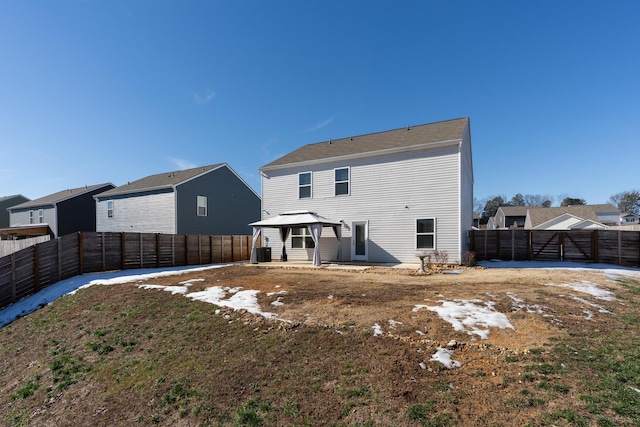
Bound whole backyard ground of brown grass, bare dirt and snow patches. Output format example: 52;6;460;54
0;263;640;426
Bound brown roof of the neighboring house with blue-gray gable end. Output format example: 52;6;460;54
96;163;226;199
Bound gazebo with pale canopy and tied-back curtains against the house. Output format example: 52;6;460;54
249;211;342;267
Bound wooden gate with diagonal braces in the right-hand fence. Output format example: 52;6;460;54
531;231;595;262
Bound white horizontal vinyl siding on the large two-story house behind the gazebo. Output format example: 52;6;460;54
262;145;464;263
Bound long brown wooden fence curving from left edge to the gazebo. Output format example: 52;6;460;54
0;232;251;309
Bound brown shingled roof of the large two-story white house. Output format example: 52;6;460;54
260;117;469;170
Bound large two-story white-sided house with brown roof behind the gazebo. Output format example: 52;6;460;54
259;118;473;263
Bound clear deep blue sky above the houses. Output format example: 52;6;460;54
0;0;640;205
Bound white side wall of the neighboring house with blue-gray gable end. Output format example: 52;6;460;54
96;192;176;234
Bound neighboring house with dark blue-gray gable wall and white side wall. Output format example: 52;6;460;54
95;163;260;235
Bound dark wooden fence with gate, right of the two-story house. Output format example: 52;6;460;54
469;229;640;267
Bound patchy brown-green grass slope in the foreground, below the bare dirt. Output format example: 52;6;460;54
0;266;640;427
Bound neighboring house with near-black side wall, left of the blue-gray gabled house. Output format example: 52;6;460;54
2;183;114;237
